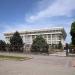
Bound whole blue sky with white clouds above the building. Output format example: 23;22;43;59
0;0;75;43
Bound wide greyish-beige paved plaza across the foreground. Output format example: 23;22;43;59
0;54;75;75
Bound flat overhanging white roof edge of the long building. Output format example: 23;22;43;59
4;27;66;36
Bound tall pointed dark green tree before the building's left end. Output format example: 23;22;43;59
10;31;23;52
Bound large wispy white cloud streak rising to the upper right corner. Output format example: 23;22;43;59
27;0;75;22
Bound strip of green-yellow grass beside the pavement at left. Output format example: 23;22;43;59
0;55;31;61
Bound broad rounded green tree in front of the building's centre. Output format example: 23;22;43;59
31;35;49;53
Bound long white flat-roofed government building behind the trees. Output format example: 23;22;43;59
4;27;67;51
